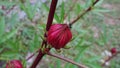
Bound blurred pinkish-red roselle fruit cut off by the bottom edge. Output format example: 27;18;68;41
6;60;23;68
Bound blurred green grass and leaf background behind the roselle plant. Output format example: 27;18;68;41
0;0;120;68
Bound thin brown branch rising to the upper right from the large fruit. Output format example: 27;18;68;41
70;0;99;25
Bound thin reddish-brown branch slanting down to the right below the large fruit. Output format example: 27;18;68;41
47;52;88;68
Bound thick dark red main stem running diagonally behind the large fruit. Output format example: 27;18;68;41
30;0;58;68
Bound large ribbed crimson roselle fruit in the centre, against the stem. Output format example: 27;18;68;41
47;24;72;49
